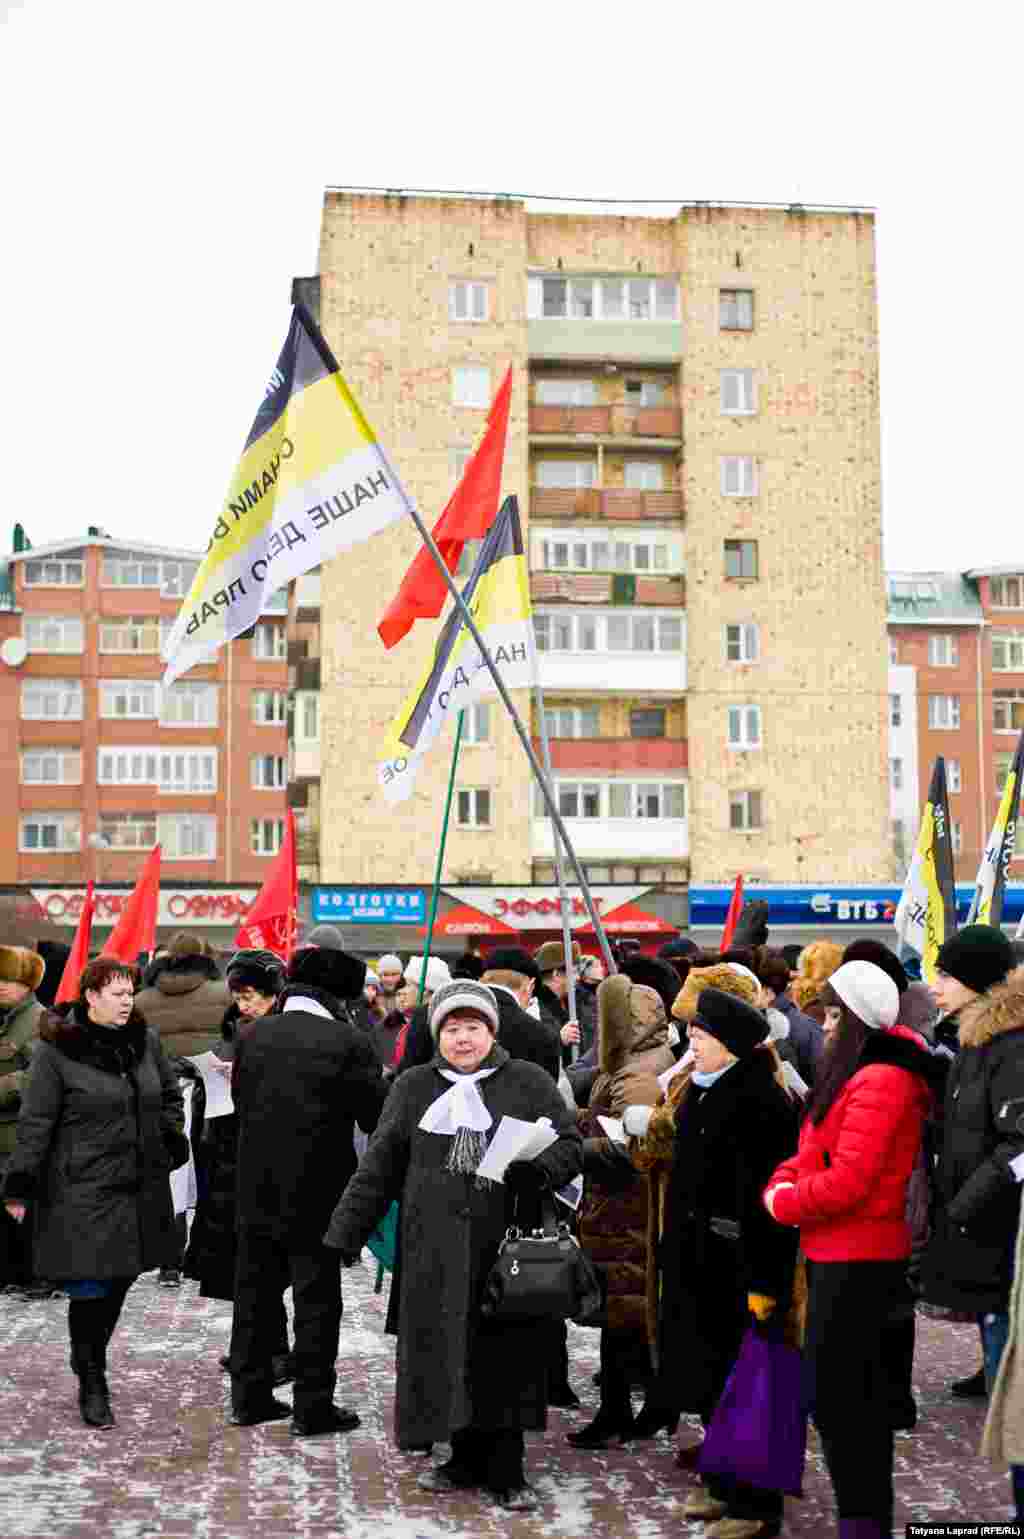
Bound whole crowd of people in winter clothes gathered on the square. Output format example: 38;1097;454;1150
0;903;1024;1539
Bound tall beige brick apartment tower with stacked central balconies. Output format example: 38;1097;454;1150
319;191;892;890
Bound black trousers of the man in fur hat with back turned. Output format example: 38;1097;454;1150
231;1228;342;1419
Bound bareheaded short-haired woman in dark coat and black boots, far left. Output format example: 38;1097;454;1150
3;957;188;1427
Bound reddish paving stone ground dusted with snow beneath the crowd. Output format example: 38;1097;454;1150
0;1260;1012;1539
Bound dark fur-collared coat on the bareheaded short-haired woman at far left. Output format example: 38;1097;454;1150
3;1005;188;1280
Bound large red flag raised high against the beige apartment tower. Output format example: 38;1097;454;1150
377;363;511;646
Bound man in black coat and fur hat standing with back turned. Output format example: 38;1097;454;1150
229;946;387;1437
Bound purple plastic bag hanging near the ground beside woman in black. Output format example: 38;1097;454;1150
699;1328;807;1496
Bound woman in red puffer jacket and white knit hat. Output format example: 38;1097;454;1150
764;962;942;1539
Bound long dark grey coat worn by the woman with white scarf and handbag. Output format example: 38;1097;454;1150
325;1047;582;1445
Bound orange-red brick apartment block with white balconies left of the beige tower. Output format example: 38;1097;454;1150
0;529;288;926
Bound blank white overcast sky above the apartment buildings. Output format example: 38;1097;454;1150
0;0;1024;568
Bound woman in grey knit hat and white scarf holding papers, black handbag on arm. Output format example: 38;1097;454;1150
325;979;582;1510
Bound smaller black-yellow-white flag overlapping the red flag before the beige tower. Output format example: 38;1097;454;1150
377;497;537;803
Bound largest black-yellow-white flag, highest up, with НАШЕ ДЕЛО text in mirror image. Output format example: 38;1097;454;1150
163;305;408;683
